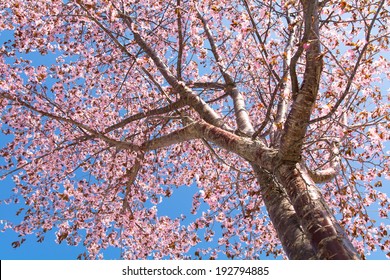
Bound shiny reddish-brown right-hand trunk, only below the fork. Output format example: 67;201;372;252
276;164;359;260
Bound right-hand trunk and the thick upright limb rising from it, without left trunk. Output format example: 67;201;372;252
258;1;358;259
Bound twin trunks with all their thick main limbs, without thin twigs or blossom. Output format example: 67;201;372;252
111;0;358;259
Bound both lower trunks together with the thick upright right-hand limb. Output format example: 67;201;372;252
250;0;359;259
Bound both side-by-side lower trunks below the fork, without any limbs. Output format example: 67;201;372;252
252;161;359;260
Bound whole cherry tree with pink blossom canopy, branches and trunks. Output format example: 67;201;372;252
0;0;390;259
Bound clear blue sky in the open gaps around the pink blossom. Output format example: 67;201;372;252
0;20;390;260
